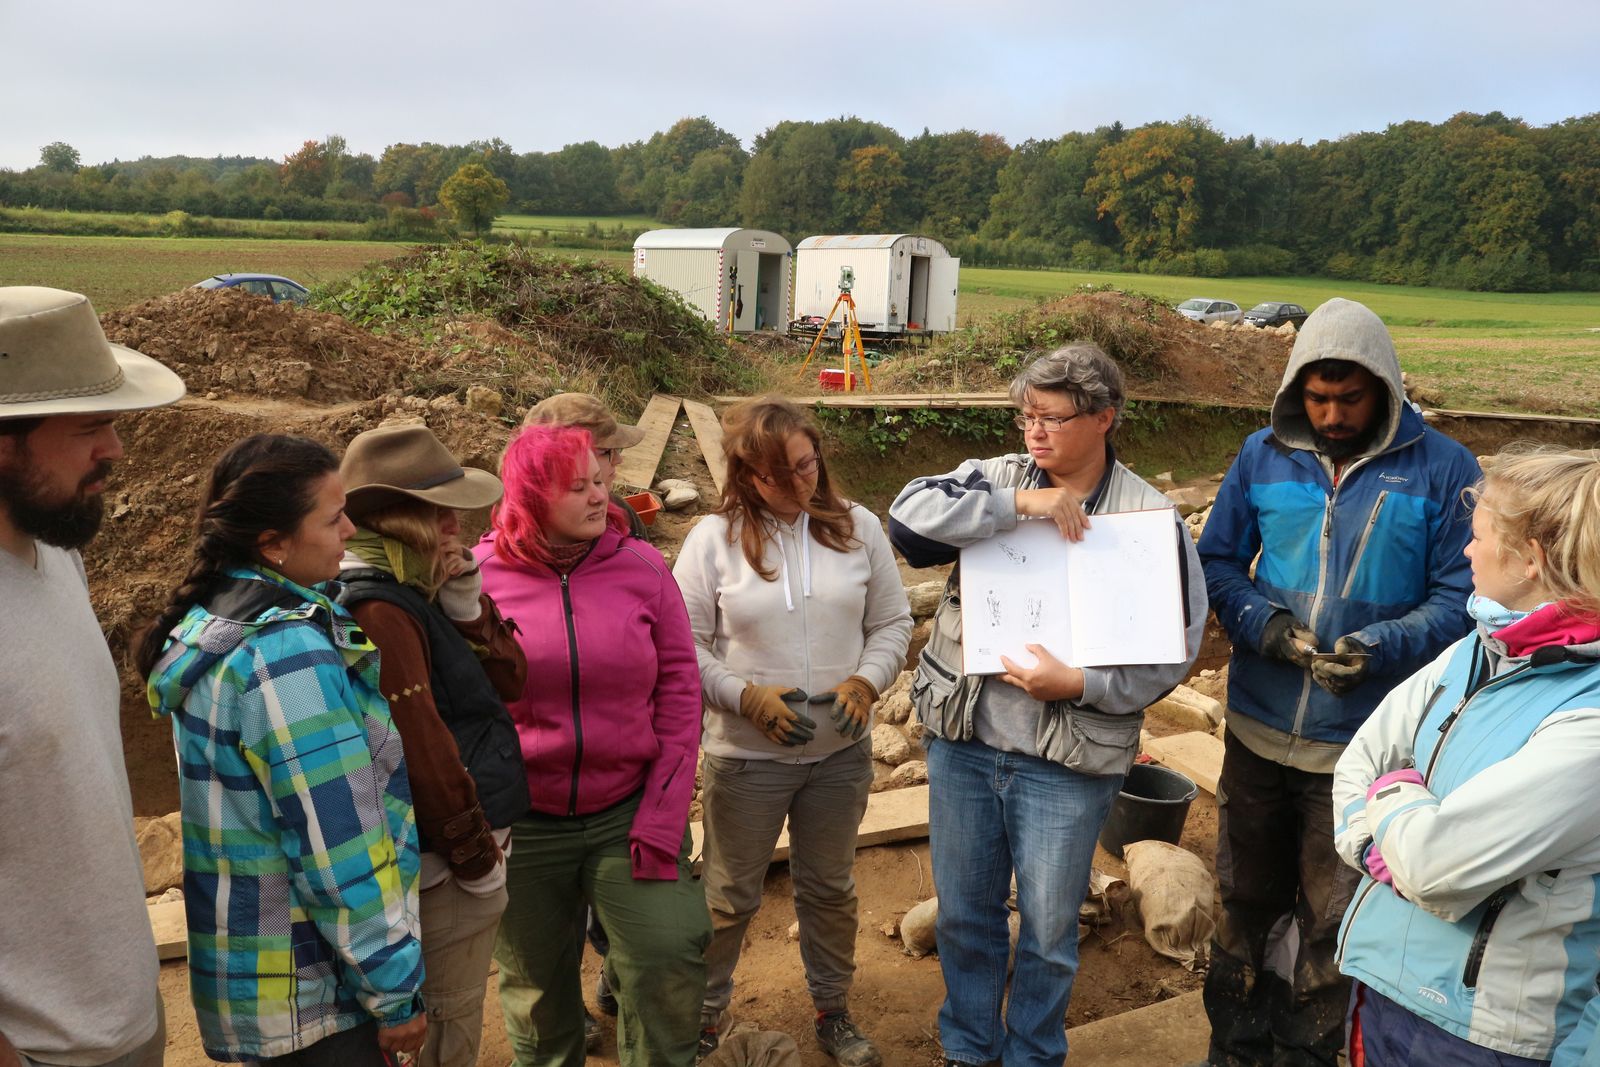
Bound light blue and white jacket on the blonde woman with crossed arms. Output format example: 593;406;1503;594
1333;627;1600;1064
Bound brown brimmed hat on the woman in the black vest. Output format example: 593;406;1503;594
339;422;506;515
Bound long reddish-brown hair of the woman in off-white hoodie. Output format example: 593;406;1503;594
714;397;858;581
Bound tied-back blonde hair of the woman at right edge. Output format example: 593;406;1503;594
1469;446;1600;616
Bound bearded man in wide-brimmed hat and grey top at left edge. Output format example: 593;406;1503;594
0;286;184;1067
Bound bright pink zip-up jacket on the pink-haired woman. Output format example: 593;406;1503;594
474;530;701;881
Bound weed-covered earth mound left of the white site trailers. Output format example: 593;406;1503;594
317;242;757;413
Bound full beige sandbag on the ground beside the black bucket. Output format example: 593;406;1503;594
1123;841;1216;971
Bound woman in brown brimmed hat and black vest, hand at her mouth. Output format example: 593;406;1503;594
339;424;528;1067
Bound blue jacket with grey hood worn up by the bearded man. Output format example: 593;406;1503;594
1198;299;1482;744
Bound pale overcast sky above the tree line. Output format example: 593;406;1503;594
0;0;1600;168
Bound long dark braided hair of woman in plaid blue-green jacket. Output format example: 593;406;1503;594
131;434;339;675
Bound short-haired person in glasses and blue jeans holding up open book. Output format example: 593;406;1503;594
890;344;1206;1067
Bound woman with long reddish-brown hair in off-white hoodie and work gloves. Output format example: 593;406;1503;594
674;397;910;1067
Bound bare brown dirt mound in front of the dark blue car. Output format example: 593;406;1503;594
101;290;429;403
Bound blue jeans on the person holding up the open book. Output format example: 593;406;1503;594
928;737;1122;1067
